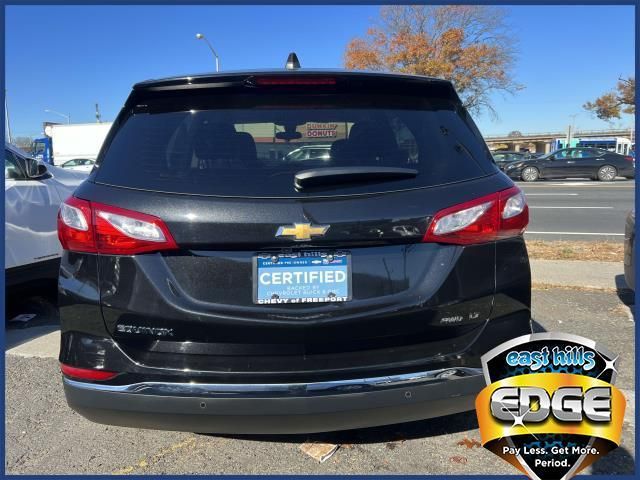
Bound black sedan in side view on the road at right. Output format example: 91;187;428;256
504;148;635;182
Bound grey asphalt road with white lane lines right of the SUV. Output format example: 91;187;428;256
517;179;635;242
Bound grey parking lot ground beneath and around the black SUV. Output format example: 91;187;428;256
5;288;635;474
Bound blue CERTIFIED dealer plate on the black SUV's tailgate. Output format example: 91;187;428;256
253;251;351;305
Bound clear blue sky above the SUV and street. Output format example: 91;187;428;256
5;5;635;137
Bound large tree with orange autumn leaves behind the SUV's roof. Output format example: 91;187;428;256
344;5;523;115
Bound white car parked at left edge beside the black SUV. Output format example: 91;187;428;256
4;144;87;287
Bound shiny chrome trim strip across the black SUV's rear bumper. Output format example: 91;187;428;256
63;367;482;397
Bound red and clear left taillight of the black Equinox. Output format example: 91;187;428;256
58;197;178;255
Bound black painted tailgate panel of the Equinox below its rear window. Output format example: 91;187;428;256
80;180;504;351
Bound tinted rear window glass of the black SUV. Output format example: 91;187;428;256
95;94;494;197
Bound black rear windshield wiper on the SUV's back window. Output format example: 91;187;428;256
294;167;418;189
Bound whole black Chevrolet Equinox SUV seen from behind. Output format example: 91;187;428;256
58;66;531;433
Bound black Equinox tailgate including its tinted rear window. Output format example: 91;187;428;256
85;71;502;369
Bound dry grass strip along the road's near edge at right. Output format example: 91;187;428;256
527;240;624;262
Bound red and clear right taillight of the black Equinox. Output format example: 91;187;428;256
423;187;529;245
